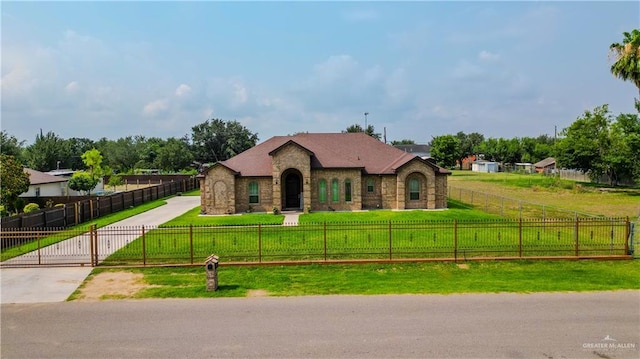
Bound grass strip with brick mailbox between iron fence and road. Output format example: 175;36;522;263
70;260;640;300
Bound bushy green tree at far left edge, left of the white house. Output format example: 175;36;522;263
0;154;31;211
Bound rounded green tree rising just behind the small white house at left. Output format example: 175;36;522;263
25;130;66;172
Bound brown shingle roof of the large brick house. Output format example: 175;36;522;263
221;132;448;176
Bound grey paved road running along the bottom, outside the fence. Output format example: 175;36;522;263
0;291;640;359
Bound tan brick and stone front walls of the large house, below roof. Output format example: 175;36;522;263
199;134;447;214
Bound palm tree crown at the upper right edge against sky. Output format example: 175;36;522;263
609;29;640;97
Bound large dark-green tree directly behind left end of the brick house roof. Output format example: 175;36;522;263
191;119;258;163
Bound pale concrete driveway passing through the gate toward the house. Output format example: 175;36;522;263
0;196;200;303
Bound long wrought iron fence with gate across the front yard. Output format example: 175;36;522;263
0;218;631;266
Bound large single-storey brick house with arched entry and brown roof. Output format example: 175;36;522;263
198;133;451;214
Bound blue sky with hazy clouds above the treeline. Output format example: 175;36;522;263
1;1;640;144
